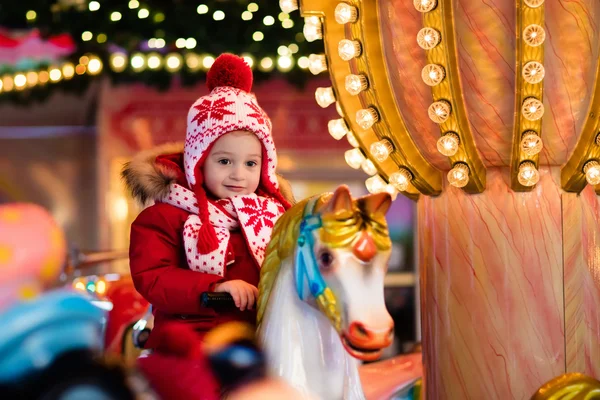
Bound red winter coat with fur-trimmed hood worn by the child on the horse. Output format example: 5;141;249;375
123;148;293;348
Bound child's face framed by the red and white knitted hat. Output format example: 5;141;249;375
202;131;262;199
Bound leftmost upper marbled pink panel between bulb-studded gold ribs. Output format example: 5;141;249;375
377;0;450;170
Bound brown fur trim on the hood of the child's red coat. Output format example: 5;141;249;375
121;142;296;204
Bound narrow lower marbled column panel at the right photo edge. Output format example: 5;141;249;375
563;186;600;378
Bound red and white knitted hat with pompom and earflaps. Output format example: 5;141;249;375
183;54;290;254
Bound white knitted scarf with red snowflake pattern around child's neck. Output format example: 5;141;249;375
162;183;285;276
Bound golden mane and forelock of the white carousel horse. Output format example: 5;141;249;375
257;193;391;325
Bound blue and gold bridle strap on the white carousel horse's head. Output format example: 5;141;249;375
294;196;342;332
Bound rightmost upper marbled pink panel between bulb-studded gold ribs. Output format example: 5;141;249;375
540;0;600;165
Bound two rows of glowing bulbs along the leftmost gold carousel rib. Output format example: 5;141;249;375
279;0;413;199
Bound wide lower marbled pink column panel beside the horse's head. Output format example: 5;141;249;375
418;168;565;400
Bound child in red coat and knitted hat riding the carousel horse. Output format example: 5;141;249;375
123;54;293;348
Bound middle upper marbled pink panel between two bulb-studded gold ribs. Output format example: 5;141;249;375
453;0;516;166
